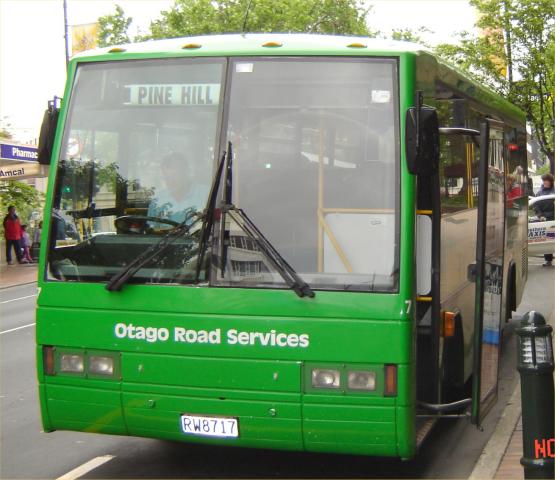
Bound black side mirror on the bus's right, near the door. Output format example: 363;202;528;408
405;105;439;176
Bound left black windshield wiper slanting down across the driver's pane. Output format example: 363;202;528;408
106;212;199;292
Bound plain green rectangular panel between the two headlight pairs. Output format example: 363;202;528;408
122;353;301;392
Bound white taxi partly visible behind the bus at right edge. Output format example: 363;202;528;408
528;194;555;256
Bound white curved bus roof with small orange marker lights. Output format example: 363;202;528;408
72;33;525;122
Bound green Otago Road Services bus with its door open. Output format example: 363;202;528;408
37;34;527;458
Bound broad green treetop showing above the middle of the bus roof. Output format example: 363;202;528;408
144;0;375;38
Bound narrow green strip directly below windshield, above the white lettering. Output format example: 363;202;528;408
37;282;408;322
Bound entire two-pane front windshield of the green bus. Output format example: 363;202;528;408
49;57;400;292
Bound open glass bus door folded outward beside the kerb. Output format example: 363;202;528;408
472;120;505;426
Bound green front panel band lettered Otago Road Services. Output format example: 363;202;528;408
37;308;413;368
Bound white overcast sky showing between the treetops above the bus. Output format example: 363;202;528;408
0;0;475;143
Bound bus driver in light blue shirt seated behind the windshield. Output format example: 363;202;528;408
148;152;208;223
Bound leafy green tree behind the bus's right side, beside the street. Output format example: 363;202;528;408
436;0;555;172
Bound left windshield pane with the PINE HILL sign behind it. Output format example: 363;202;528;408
49;59;224;283
